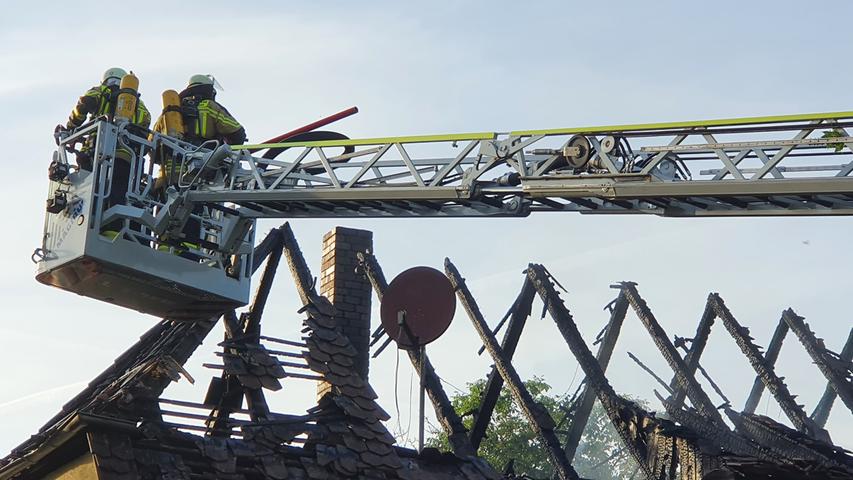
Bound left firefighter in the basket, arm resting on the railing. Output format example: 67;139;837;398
65;67;151;170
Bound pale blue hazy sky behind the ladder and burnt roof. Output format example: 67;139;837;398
0;0;853;455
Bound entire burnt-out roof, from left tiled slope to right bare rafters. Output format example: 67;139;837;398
0;224;853;480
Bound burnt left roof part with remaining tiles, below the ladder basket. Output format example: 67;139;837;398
0;225;500;480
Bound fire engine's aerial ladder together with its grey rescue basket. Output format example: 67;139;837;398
33;112;853;316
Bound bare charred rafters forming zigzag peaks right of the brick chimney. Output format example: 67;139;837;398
360;246;853;480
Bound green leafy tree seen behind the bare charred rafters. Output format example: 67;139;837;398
427;377;636;480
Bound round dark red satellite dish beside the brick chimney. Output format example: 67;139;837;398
379;267;456;349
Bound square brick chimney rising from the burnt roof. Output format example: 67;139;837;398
320;227;373;380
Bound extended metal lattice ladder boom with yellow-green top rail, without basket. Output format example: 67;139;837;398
187;112;853;217
